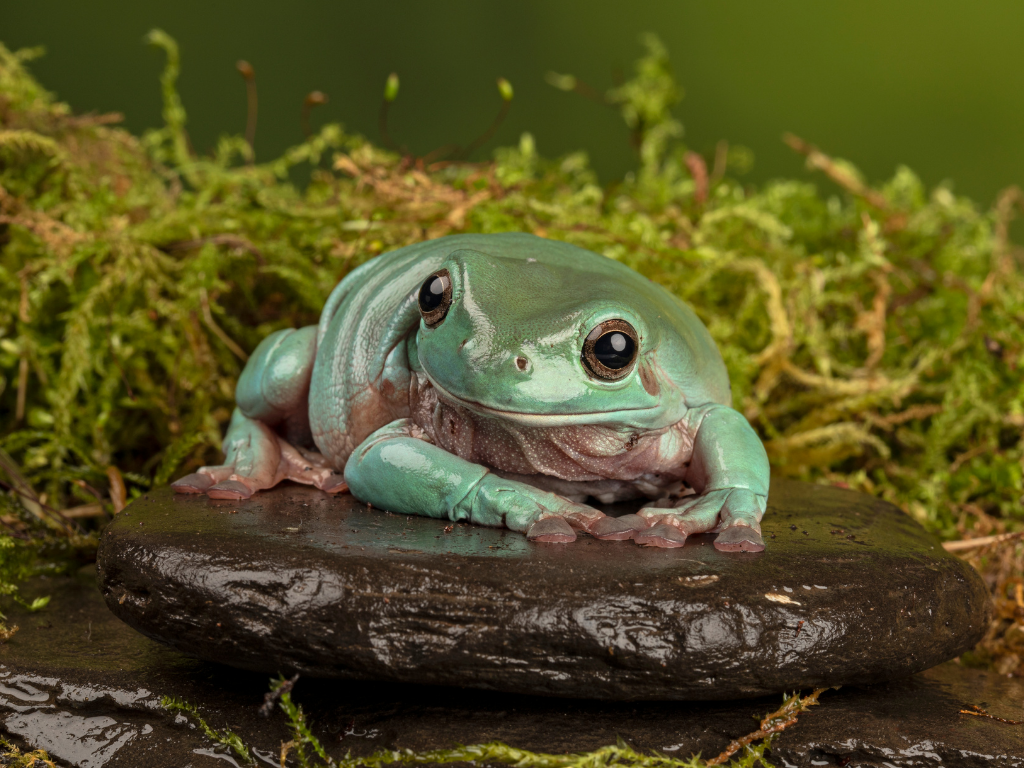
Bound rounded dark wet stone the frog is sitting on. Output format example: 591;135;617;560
99;480;988;699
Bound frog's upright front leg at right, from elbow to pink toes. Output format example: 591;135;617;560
634;406;769;552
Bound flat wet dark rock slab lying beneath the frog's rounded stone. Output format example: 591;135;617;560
0;571;1024;768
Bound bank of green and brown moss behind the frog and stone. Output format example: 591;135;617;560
0;27;1024;761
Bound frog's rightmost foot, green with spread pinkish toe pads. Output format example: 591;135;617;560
634;488;765;552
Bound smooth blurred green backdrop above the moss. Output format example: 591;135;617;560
0;0;1024;205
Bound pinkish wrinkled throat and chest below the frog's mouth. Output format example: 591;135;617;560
410;377;693;493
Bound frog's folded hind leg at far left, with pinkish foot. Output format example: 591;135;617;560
171;327;344;499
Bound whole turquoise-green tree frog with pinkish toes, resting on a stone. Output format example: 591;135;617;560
174;232;769;552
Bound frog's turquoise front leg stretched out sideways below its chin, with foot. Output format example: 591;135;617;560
345;419;630;544
